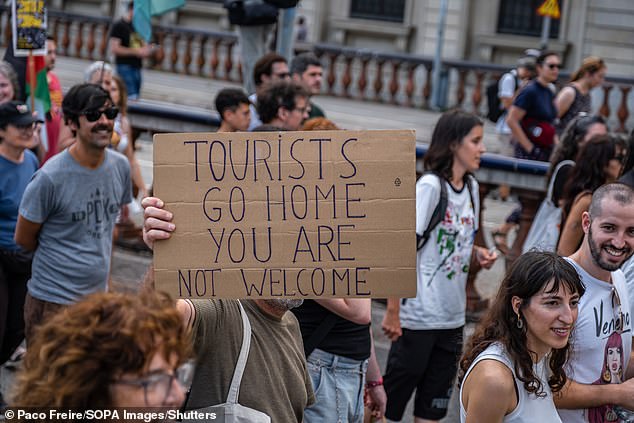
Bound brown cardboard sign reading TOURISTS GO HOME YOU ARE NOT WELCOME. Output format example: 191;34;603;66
154;130;416;298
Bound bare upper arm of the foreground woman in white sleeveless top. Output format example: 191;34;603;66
460;360;517;423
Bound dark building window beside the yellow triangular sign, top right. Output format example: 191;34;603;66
497;0;563;38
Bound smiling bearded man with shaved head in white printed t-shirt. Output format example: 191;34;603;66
543;183;634;423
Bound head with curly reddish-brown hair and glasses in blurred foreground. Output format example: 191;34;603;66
12;292;192;411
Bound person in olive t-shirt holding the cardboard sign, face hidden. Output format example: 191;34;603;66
141;197;315;423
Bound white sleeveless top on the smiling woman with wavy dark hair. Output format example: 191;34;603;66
460;343;561;423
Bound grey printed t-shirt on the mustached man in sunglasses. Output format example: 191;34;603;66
20;149;132;304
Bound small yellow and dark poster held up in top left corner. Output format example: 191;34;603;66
11;0;47;57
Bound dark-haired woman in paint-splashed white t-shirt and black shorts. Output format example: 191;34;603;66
383;110;497;420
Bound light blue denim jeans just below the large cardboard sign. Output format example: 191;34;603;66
304;349;368;423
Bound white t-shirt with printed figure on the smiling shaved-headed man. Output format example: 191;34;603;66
559;259;632;423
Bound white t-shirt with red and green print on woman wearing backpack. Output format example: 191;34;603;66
400;174;480;330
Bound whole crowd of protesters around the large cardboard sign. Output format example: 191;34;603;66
0;0;634;423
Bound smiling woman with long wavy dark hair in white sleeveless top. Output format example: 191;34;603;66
459;252;585;423
